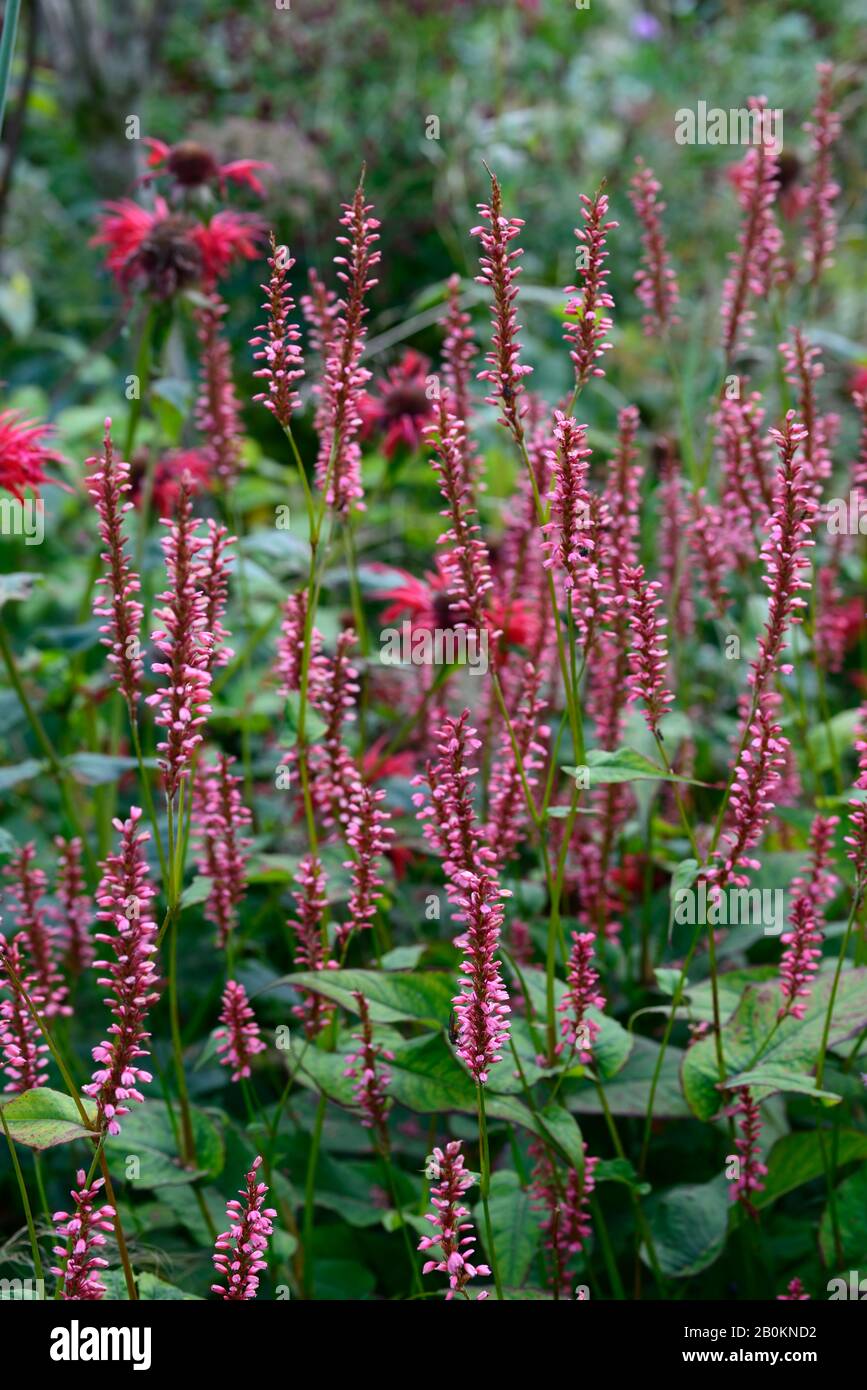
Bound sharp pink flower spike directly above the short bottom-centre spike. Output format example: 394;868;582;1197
452;872;511;1086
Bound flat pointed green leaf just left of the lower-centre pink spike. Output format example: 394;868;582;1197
272;970;456;1027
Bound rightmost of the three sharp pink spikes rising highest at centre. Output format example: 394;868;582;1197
563;188;620;389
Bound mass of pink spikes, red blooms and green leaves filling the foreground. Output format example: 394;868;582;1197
0;7;867;1300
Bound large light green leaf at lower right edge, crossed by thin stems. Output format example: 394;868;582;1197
681;967;867;1120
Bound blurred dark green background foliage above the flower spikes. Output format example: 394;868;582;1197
0;0;867;452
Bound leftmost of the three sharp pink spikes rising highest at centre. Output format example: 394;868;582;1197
317;171;379;513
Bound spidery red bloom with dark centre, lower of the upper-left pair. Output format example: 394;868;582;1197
92;197;263;299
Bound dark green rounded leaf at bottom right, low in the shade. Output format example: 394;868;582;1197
642;1177;729;1279
